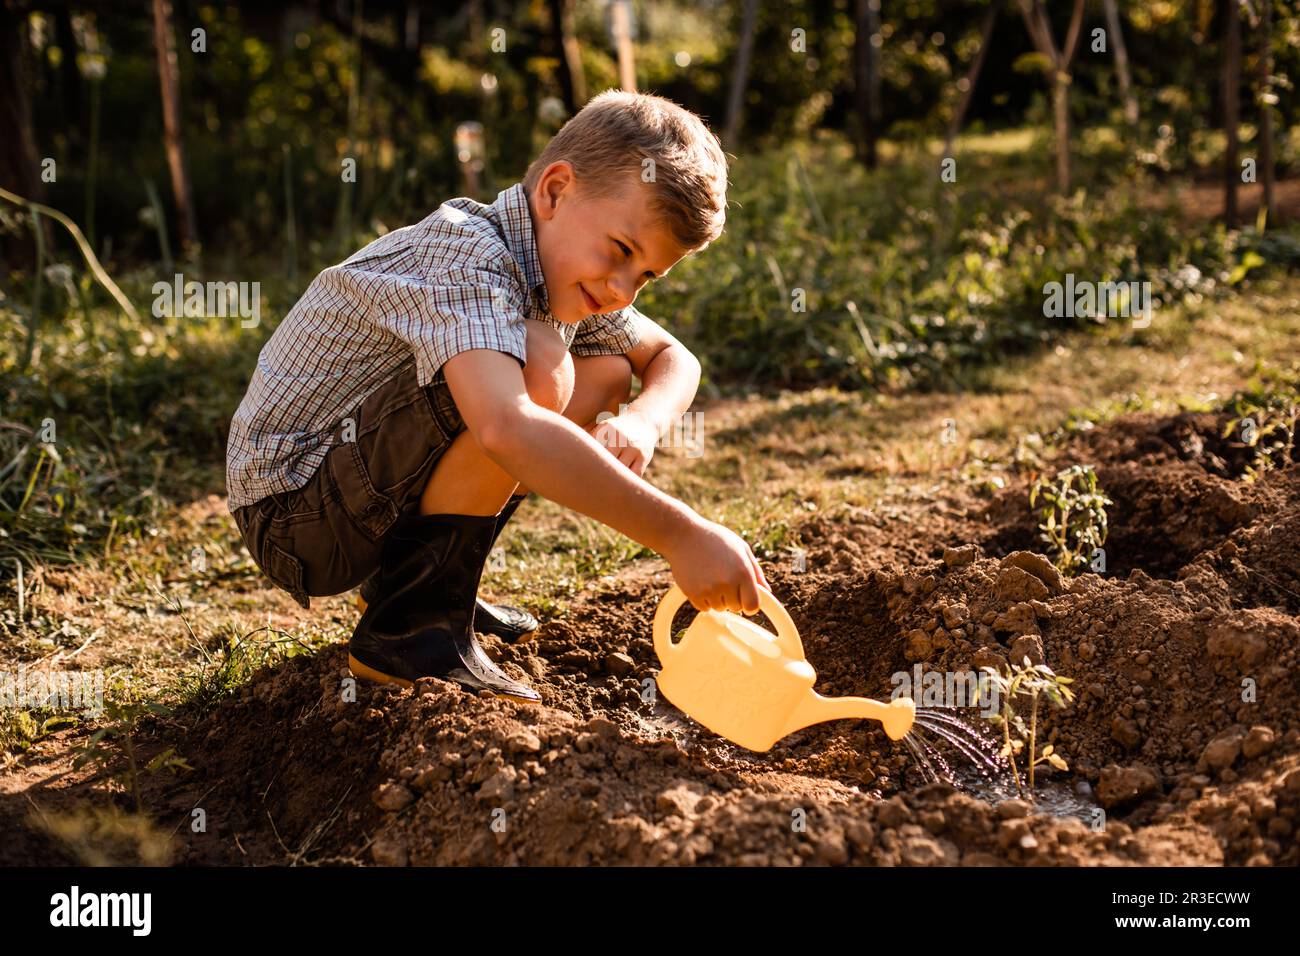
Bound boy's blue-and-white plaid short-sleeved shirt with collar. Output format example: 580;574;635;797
226;183;641;511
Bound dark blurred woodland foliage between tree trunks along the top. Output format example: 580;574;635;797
0;0;1300;265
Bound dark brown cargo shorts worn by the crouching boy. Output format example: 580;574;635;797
231;359;464;607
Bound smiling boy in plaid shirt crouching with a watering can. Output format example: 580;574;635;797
226;90;767;702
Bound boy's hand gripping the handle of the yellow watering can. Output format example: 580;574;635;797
664;519;772;614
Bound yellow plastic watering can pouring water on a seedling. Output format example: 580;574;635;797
654;584;917;752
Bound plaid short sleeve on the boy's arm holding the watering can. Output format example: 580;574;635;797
361;267;528;385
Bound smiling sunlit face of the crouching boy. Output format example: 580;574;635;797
529;160;688;324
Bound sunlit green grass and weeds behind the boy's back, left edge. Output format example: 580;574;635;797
0;267;266;580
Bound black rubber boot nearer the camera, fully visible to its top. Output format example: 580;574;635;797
347;515;541;704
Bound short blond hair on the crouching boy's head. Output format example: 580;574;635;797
524;90;727;252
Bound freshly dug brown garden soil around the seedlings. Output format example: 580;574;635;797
0;415;1300;865
